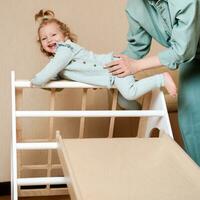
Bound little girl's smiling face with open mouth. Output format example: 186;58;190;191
39;22;65;54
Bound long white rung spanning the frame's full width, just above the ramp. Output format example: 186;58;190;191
16;110;164;117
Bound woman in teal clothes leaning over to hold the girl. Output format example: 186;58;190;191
107;0;200;165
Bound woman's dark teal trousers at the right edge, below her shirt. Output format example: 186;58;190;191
178;59;200;166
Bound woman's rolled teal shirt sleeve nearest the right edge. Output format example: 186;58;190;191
158;1;200;69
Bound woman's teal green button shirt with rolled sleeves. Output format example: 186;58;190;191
124;0;200;69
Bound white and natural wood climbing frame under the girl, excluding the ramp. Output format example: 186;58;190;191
11;71;173;200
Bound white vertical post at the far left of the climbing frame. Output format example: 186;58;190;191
11;71;18;200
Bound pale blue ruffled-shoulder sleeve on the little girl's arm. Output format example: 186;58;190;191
31;44;74;87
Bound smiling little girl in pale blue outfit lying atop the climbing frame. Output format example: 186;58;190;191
31;10;176;107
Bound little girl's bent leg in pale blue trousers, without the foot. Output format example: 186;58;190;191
114;74;164;100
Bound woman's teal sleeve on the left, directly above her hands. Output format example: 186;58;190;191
122;11;152;59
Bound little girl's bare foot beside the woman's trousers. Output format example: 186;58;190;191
163;72;177;97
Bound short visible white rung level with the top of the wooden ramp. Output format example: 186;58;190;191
16;142;58;150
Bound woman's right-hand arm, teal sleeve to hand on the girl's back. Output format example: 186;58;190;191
106;1;200;77
